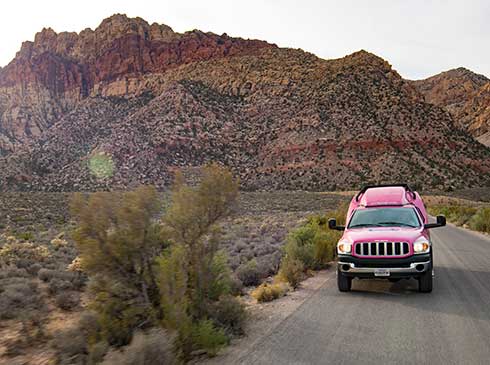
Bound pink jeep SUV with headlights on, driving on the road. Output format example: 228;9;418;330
328;184;446;293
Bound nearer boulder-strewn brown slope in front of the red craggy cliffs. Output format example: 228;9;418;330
0;34;490;190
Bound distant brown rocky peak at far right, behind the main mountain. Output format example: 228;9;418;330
413;68;490;146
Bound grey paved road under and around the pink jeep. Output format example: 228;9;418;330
238;226;490;365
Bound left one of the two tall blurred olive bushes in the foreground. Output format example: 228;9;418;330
66;187;168;345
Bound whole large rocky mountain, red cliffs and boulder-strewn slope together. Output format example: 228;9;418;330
0;15;490;191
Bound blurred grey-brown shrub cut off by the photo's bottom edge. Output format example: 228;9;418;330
103;328;177;365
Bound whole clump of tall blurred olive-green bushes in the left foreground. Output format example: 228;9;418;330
59;165;245;363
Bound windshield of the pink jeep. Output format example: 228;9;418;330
348;207;420;228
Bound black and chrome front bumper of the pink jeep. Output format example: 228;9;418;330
338;254;432;279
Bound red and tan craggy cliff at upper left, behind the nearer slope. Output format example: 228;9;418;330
0;14;274;155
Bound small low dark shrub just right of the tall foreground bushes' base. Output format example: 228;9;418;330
208;295;247;335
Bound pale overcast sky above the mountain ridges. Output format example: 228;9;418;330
0;0;490;79
